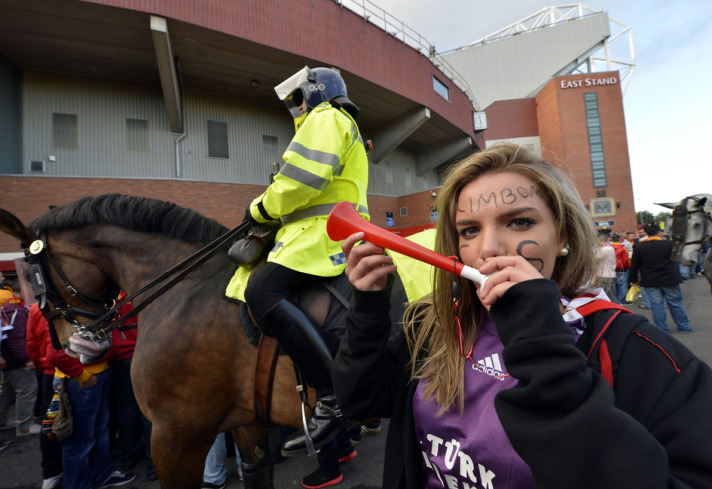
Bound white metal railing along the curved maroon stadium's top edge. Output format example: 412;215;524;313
334;0;480;111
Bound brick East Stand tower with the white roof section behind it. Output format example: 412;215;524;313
443;4;636;231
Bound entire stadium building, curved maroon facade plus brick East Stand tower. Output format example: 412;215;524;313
0;0;635;270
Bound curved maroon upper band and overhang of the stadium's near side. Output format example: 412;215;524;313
0;0;484;168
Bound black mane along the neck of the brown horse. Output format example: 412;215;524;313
30;194;227;244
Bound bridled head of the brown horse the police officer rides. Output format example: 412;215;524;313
0;209;118;363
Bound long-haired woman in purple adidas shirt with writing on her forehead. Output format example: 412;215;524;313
332;144;712;489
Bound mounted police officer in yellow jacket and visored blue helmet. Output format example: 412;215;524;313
238;67;369;456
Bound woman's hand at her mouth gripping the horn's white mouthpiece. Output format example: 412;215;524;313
477;256;543;311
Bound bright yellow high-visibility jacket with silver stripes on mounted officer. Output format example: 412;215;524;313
226;102;370;300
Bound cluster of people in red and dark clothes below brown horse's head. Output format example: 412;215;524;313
0;280;157;489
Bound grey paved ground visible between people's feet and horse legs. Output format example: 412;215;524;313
0;277;712;489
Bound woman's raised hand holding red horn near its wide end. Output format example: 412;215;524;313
341;232;396;291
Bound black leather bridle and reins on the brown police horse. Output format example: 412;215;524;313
25;217;253;349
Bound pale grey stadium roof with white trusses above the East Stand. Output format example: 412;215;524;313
442;3;636;107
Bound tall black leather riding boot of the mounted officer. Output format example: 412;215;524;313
262;299;344;457
